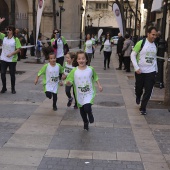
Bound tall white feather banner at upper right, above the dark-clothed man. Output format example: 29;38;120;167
113;3;123;36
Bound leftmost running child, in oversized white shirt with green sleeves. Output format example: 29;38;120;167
35;53;63;111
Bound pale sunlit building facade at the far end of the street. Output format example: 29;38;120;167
85;0;147;36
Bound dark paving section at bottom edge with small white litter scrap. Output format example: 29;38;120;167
38;157;144;170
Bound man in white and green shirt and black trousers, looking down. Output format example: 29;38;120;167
131;27;157;115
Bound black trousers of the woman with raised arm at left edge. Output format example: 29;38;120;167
1;60;17;89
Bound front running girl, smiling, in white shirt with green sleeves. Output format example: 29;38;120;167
66;51;103;130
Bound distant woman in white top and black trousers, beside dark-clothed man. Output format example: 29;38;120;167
100;33;113;70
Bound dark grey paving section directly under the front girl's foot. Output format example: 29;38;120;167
49;126;138;152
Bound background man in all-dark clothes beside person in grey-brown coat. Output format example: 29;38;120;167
116;33;124;70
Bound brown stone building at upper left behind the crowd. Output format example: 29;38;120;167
0;0;86;47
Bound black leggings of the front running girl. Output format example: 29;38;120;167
80;103;94;123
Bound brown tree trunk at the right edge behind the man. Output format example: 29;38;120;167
164;19;170;106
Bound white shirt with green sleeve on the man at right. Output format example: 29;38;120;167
131;38;157;73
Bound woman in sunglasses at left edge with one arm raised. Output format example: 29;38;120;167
0;18;21;94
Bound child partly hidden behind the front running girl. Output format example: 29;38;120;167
62;52;78;109
